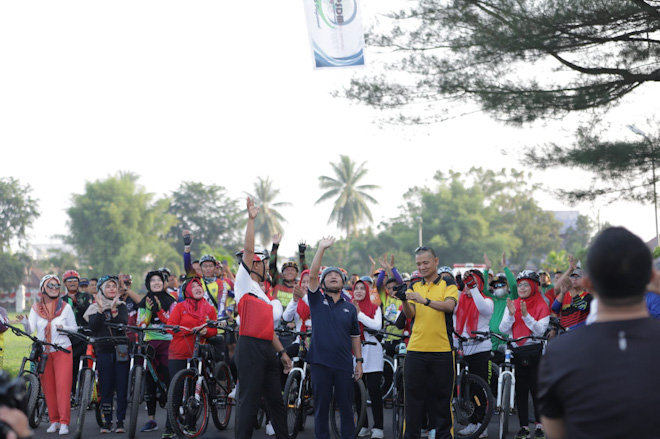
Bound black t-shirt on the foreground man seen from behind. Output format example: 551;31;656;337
539;318;660;439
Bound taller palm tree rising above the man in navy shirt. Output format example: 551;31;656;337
315;155;379;237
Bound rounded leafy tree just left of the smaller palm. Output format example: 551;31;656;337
167;181;245;256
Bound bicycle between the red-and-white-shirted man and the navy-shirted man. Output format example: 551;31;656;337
277;328;314;439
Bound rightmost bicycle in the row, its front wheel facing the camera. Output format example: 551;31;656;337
472;331;548;439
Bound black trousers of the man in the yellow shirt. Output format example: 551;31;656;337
403;351;456;439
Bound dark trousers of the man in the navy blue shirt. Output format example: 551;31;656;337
312;363;355;439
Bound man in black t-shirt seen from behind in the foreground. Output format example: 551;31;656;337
539;227;660;439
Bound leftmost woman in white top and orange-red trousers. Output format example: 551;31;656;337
16;274;78;435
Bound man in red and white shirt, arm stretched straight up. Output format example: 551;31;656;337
234;197;292;439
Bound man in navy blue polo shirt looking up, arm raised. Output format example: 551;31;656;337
307;237;364;439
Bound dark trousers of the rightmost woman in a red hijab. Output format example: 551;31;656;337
513;349;541;427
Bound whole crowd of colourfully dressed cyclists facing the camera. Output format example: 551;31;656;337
5;199;648;439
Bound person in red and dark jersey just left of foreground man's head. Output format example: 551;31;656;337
552;268;593;331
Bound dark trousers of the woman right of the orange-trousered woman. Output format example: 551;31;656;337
96;353;130;422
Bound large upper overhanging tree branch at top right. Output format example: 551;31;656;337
345;0;660;124
